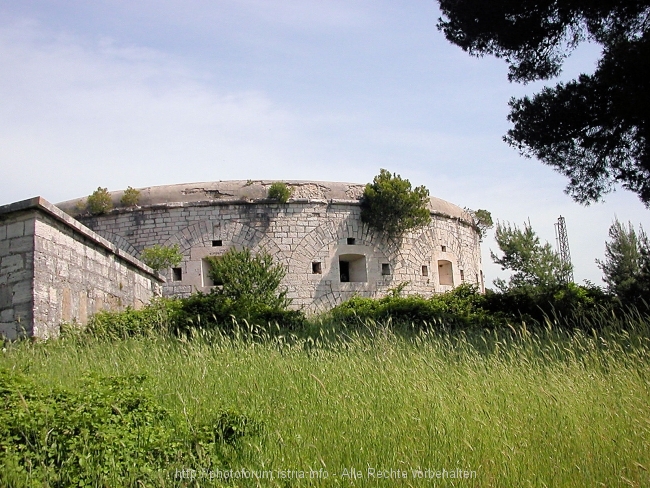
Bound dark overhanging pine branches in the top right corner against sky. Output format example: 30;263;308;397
438;0;650;207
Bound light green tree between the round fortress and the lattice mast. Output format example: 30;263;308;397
490;222;571;292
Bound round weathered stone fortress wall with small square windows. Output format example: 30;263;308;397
59;181;483;312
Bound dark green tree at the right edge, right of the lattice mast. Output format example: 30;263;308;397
596;219;650;305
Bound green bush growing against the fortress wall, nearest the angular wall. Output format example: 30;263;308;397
207;248;290;310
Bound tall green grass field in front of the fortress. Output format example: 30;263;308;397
0;320;650;487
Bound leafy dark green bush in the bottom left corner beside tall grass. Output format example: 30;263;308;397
0;370;262;487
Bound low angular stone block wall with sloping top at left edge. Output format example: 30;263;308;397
0;197;163;339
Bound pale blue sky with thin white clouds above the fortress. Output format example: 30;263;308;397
0;0;650;283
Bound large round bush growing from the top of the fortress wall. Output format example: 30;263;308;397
361;169;431;237
